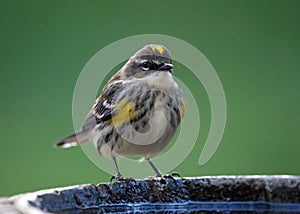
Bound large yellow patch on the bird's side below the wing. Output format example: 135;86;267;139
110;100;134;126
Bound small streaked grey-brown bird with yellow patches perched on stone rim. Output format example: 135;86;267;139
56;44;186;180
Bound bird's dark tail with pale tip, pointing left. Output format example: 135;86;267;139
54;131;89;148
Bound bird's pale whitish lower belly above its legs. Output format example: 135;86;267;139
94;108;178;158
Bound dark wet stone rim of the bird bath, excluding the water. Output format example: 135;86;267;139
0;176;300;213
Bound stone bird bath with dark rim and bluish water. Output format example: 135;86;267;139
0;176;300;214
